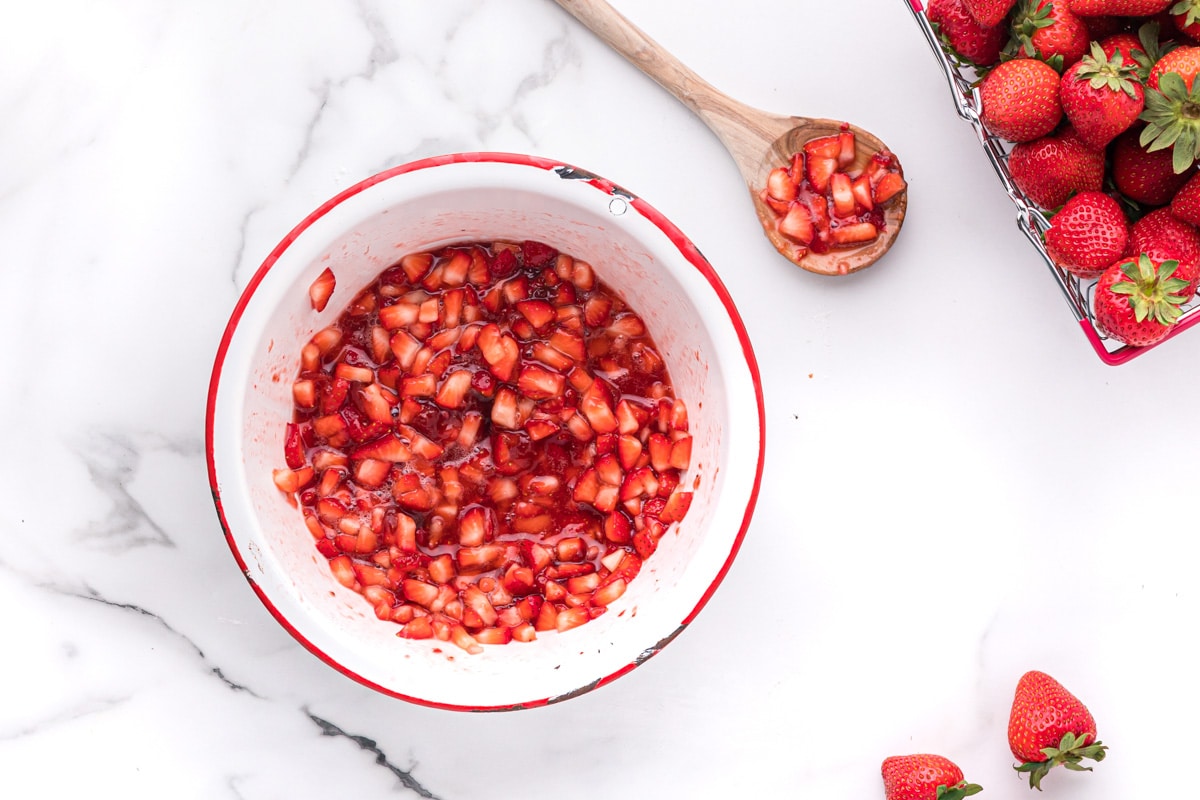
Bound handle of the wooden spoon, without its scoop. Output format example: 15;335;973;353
556;0;790;165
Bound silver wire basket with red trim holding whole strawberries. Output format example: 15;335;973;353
905;0;1200;366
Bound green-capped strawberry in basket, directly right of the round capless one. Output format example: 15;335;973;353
1058;42;1145;150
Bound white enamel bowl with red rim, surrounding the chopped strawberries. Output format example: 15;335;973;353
209;156;762;709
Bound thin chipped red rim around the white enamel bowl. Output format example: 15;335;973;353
204;152;767;711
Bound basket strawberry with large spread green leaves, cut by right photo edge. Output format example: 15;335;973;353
1139;47;1200;173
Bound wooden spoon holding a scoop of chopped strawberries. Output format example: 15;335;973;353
556;0;908;275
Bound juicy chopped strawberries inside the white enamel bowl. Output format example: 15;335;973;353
274;241;692;652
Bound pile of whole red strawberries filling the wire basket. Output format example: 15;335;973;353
926;0;1200;345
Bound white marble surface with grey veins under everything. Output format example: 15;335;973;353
0;0;1200;800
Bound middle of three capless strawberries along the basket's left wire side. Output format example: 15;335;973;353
1008;128;1104;209
